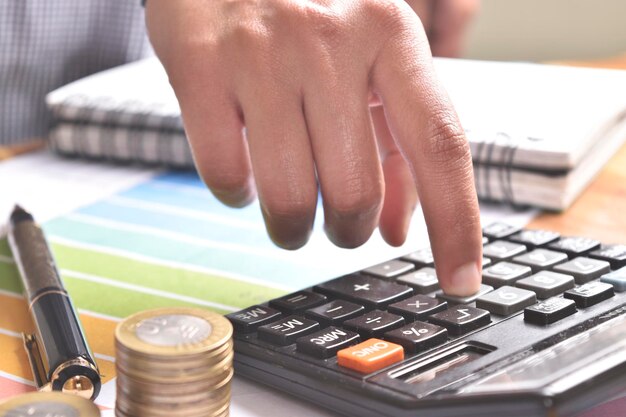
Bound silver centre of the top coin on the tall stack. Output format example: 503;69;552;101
135;314;213;346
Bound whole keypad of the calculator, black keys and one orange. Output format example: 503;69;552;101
228;223;626;375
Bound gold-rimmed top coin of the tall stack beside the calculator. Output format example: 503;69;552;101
115;308;233;357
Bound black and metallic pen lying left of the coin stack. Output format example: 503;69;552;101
9;206;101;399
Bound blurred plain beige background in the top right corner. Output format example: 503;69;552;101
464;0;626;61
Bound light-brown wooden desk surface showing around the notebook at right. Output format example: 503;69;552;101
529;55;626;243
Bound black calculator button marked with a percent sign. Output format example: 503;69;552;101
385;321;448;353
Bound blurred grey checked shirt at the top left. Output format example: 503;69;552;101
0;0;150;145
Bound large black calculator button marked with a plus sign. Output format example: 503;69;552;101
315;274;413;307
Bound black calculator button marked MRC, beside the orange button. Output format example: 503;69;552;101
296;326;359;359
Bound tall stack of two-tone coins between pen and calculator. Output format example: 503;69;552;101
115;308;233;417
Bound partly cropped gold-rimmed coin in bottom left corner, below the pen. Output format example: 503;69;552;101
0;392;100;417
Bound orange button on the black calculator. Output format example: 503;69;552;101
337;339;404;374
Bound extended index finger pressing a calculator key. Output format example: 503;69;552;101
372;5;482;296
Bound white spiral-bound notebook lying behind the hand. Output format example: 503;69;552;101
47;58;626;210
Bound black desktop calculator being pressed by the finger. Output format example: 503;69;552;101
227;223;626;417
